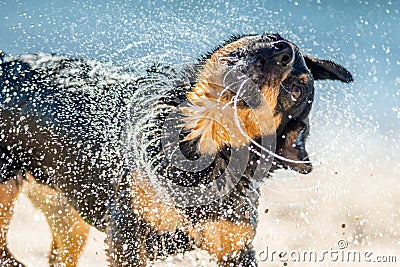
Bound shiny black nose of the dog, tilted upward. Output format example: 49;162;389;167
258;40;294;66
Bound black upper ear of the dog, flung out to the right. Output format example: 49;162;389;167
303;55;353;83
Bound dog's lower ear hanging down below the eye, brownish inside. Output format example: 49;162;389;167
277;120;312;174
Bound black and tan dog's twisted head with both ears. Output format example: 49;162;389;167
183;34;353;173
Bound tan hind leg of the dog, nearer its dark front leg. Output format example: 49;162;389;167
23;173;90;267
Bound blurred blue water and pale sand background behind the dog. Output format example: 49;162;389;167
0;0;400;266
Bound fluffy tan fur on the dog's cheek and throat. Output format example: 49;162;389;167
181;61;288;154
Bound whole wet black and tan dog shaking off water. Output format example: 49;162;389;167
0;34;352;266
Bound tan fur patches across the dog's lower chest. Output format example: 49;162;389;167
131;174;255;261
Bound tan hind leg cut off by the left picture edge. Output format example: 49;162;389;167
0;180;20;266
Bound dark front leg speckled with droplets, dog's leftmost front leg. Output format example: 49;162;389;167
107;177;147;267
